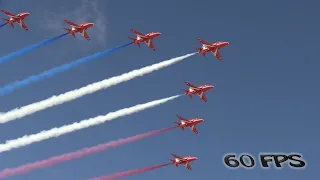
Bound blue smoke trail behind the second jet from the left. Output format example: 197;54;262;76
0;33;68;64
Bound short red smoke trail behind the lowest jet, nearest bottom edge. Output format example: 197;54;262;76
89;163;172;180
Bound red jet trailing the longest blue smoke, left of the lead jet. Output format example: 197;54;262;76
129;29;161;51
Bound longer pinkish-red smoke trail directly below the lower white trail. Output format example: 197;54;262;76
0;127;176;179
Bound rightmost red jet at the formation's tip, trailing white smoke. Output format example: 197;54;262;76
196;38;229;60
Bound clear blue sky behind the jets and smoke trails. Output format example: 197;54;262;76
0;0;320;180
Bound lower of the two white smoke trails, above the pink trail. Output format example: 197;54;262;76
0;95;181;152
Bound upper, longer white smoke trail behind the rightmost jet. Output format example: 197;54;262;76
0;52;197;123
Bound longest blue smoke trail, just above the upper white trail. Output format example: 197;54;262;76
0;42;133;95
